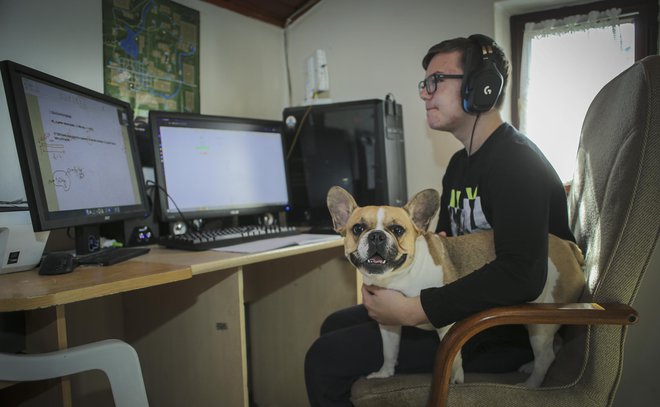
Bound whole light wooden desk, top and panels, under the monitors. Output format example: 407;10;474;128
0;240;357;406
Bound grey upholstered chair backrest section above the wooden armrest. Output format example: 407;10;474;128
569;55;660;305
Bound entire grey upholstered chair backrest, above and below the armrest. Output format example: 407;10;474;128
544;55;660;405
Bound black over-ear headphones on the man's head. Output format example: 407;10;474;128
461;34;504;113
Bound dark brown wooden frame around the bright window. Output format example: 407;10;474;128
509;0;658;127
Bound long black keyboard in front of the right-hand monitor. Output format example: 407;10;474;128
158;225;300;251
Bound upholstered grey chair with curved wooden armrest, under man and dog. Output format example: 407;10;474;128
351;55;660;407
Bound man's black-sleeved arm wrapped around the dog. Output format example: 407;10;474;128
420;146;550;327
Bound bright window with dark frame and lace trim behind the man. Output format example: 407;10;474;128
511;0;658;182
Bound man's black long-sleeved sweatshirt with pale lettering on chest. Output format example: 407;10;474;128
421;123;575;327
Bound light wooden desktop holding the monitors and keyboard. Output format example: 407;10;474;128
0;239;343;312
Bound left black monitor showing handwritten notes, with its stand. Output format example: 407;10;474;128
0;61;148;254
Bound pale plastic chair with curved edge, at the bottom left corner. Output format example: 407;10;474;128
0;339;149;407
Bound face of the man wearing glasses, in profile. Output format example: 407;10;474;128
420;51;466;133
